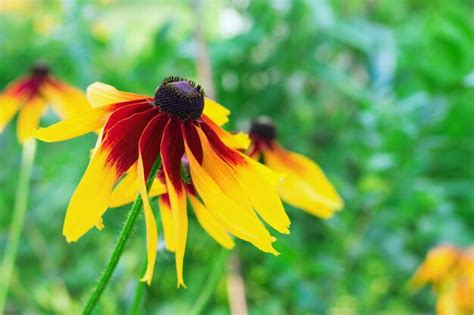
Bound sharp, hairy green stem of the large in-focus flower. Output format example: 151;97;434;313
82;158;161;314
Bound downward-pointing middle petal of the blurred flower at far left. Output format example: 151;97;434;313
17;97;46;143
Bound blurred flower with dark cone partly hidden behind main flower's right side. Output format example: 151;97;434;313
247;117;344;219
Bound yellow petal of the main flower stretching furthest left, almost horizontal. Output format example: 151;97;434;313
34;107;109;142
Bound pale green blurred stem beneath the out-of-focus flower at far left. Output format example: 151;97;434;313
0;139;36;314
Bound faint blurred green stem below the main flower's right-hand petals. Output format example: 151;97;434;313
189;248;231;315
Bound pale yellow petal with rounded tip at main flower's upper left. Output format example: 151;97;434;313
87;82;148;107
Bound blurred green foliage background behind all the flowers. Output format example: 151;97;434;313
0;0;474;314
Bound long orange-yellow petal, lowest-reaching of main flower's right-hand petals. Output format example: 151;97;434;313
184;123;278;255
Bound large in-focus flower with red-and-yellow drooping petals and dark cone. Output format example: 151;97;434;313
36;77;290;286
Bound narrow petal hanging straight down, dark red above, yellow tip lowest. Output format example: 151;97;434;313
160;118;188;287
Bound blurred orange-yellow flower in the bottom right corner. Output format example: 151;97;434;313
410;245;474;315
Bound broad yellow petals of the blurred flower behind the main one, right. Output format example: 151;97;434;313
264;143;343;218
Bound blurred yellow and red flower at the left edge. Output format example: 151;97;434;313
0;64;89;143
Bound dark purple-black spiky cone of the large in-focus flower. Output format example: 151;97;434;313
155;77;204;120
